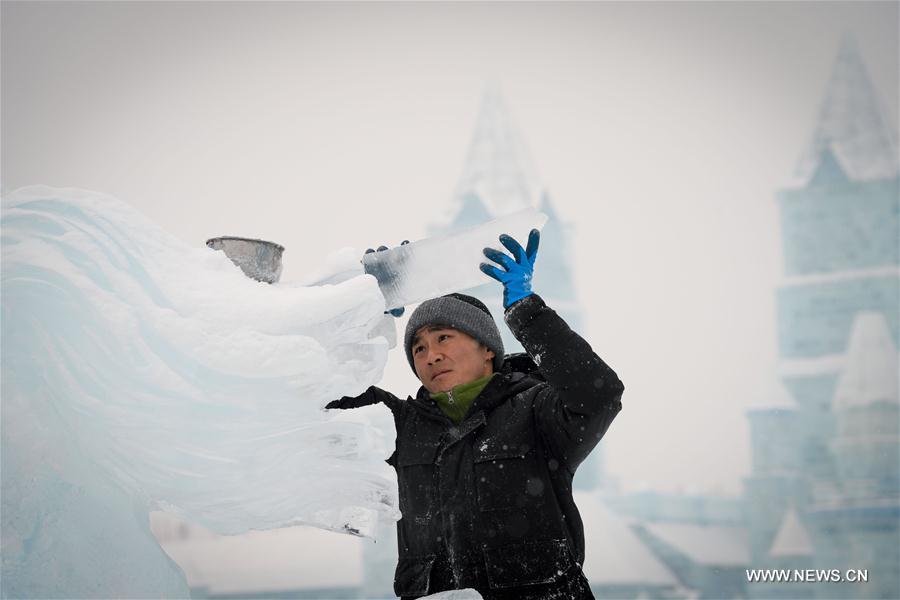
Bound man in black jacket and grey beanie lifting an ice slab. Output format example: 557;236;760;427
327;230;624;600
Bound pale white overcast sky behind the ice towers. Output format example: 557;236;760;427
2;1;900;494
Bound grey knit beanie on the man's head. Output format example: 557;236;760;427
403;294;503;373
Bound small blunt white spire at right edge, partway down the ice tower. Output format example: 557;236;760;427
834;312;898;409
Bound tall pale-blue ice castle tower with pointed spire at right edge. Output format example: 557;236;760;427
745;38;900;598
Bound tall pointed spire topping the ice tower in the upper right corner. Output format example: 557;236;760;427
793;35;898;187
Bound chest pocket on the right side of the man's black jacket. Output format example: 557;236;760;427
474;447;536;511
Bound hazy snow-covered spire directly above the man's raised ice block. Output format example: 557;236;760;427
455;82;540;216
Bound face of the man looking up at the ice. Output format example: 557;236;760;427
412;325;494;393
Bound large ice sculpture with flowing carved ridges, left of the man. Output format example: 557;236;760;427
0;187;399;598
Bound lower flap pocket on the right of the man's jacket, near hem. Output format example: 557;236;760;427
484;539;574;588
